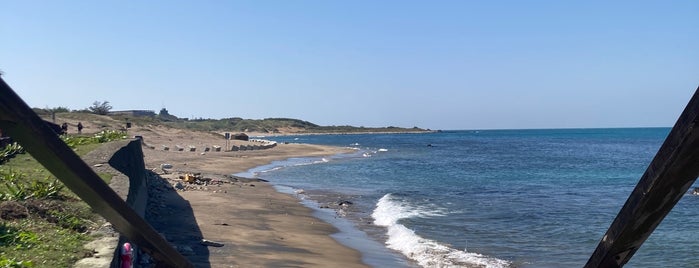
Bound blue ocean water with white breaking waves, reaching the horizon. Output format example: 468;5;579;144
237;128;699;267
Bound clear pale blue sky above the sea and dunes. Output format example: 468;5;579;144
0;0;699;129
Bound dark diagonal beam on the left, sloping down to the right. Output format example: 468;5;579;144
0;78;193;267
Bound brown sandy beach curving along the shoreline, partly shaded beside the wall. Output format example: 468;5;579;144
129;126;367;267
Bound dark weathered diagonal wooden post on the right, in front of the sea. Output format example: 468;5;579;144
585;85;699;268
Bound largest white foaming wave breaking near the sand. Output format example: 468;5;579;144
371;194;510;268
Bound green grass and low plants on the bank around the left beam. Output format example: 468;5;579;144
0;131;125;268
